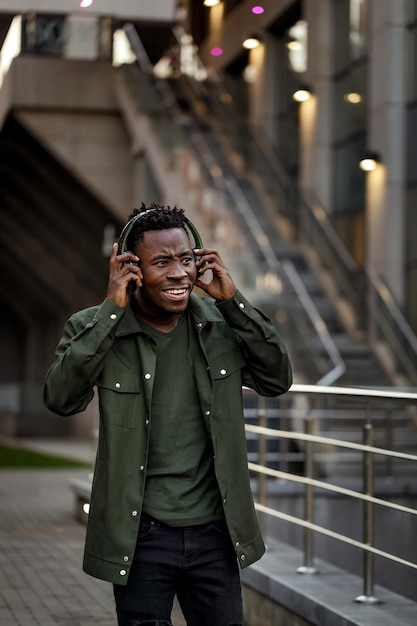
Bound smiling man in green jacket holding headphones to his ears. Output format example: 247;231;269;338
45;204;292;626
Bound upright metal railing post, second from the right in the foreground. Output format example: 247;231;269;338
297;418;318;574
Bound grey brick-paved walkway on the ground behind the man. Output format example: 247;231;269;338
0;438;185;626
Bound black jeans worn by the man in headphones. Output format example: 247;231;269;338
114;515;243;626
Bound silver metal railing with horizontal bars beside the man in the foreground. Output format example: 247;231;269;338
245;384;417;604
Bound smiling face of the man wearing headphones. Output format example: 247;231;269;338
133;228;197;325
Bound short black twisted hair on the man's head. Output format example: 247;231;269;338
127;202;187;250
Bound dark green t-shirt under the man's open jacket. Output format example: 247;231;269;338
143;315;223;526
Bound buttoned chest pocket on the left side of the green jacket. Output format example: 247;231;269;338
97;368;142;428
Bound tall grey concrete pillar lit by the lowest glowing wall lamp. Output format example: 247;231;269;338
366;0;406;304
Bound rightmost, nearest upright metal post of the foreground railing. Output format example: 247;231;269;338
355;423;380;604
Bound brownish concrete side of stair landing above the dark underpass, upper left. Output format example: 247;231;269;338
4;55;134;219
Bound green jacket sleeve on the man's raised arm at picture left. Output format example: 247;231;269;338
44;299;125;415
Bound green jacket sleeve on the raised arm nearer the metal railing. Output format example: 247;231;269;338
217;291;292;396
